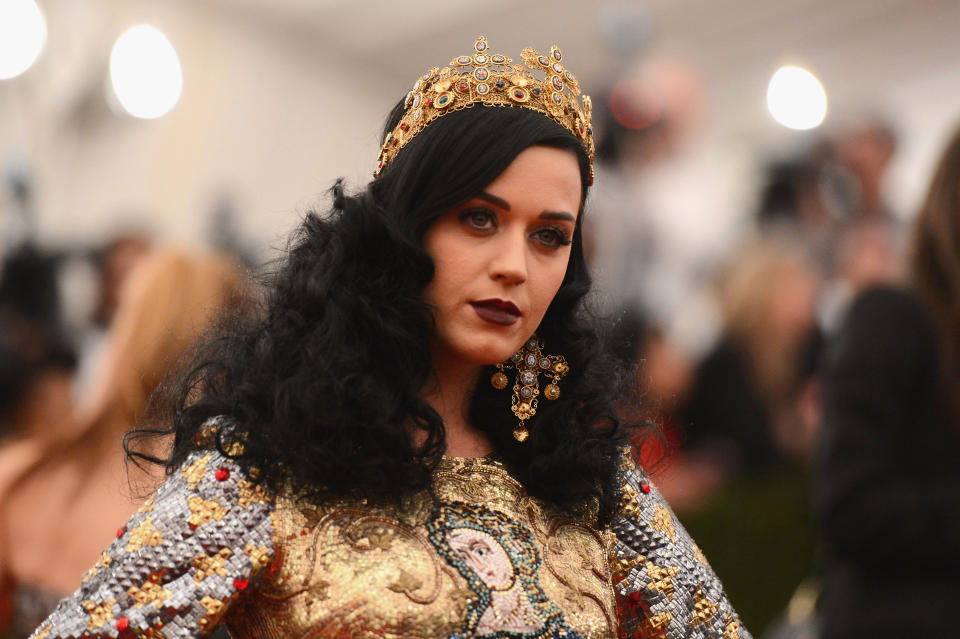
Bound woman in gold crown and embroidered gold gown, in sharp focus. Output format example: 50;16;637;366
28;37;748;639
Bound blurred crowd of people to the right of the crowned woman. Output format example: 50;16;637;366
587;62;960;638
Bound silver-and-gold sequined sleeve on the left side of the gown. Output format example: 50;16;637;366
32;451;273;639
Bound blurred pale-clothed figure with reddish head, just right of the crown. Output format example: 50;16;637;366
587;61;742;370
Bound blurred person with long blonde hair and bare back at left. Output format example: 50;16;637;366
0;249;249;639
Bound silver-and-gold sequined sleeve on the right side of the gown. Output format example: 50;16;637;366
612;455;750;639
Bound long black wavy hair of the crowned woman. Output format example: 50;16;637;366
126;102;632;521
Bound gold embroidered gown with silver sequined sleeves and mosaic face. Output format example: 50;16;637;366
33;422;750;639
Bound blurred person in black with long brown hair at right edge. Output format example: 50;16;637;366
813;120;960;639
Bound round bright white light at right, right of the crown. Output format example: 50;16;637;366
767;67;827;130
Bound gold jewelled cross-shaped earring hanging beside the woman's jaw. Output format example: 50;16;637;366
490;334;570;442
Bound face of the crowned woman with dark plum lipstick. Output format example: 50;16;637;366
423;146;581;366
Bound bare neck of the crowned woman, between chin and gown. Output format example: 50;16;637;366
424;361;493;457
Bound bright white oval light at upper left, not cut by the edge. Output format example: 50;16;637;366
110;24;183;119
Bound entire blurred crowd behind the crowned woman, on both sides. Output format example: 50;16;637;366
0;69;960;639
